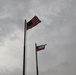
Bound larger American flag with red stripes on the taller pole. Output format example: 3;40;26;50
27;16;41;30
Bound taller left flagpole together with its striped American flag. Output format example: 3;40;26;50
23;16;41;75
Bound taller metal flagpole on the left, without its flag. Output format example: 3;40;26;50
23;20;27;75
